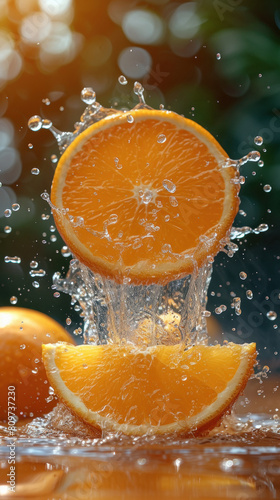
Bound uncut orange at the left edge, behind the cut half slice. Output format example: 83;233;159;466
0;307;74;421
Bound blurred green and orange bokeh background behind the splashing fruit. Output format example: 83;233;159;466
0;0;280;371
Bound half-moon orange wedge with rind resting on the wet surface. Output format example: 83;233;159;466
43;343;256;435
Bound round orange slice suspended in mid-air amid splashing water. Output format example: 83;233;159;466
51;109;239;284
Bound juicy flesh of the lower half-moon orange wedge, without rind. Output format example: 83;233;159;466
44;344;255;426
